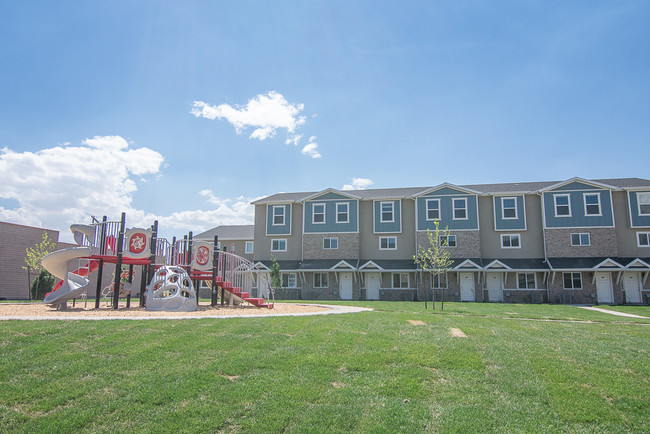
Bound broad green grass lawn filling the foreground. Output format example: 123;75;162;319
0;302;650;432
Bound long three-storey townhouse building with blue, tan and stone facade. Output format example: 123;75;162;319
250;178;650;304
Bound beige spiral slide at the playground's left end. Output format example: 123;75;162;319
41;247;98;305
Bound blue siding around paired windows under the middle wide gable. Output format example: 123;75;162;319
417;195;478;231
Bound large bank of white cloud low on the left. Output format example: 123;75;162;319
0;136;255;241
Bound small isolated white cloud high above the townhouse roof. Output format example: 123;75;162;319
191;91;306;140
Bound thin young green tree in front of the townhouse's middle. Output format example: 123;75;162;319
413;220;453;310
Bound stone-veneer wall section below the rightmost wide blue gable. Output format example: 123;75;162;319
545;228;618;258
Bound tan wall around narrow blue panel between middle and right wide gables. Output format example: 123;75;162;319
474;194;544;259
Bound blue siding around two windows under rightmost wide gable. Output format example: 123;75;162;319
544;189;614;228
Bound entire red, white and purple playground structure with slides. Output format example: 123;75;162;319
42;213;274;311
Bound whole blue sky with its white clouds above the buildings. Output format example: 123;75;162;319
0;0;650;241
